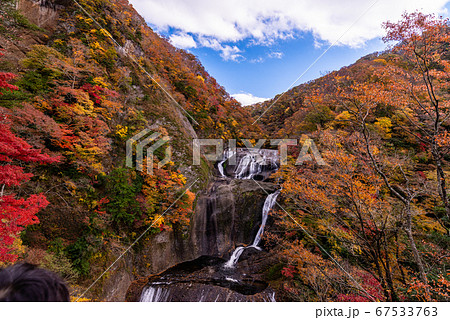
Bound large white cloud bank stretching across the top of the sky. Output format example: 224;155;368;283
131;0;447;48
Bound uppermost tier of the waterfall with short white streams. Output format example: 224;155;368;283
217;148;279;181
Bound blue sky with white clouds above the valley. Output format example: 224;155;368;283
131;0;450;104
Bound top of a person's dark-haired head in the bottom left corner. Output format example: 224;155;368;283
0;263;70;302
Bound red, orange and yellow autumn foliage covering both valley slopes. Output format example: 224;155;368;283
0;0;450;301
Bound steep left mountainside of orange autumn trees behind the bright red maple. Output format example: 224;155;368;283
0;0;259;300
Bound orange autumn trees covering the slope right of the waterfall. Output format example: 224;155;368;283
262;12;450;301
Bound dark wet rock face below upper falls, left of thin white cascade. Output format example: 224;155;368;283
191;179;276;257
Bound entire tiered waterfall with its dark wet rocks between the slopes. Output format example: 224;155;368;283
135;148;280;302
